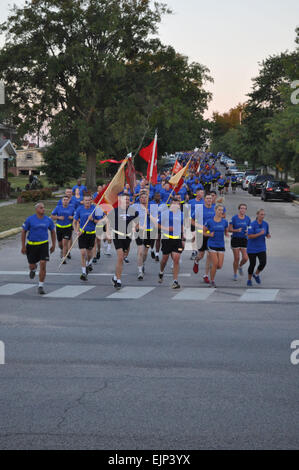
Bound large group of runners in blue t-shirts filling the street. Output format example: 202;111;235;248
21;153;270;294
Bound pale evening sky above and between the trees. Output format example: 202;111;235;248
0;0;299;117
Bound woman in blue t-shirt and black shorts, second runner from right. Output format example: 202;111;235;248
228;204;251;281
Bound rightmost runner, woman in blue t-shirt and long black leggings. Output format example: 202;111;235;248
247;209;271;287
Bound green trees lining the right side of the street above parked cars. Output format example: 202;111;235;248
211;28;299;181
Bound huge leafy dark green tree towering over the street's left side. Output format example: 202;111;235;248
0;0;212;187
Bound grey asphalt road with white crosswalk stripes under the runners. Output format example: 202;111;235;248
0;185;299;450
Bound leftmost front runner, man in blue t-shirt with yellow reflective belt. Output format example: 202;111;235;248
21;202;56;295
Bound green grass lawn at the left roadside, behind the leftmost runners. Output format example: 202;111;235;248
0;200;57;232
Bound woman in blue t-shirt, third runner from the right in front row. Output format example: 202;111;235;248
203;204;228;287
